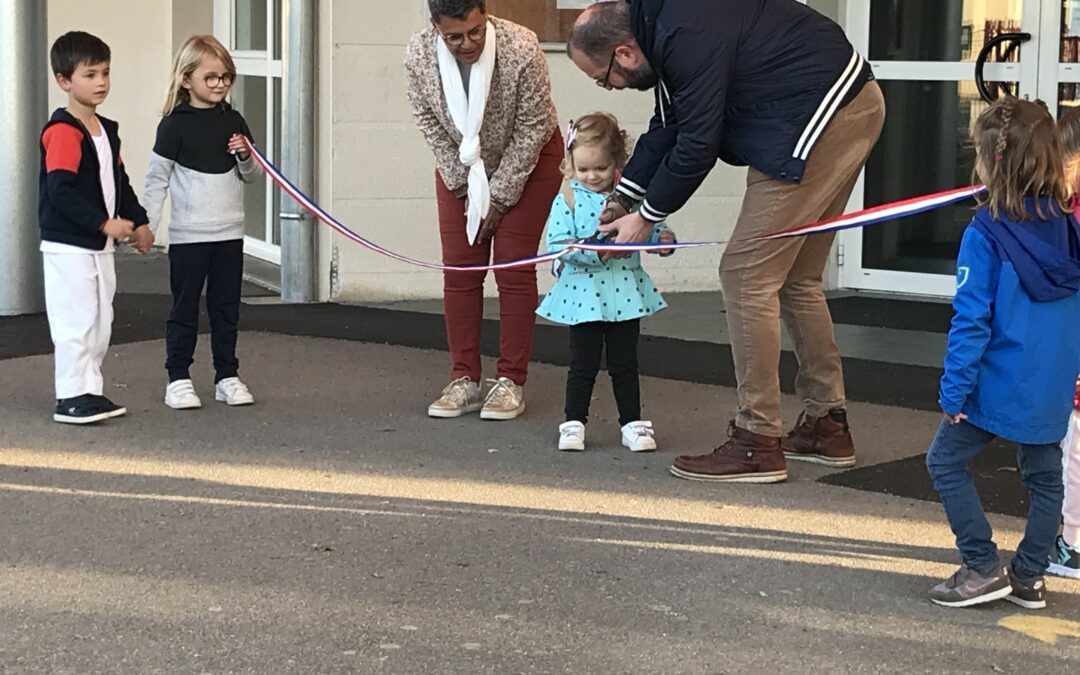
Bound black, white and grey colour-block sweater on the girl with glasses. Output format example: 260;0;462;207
143;103;259;244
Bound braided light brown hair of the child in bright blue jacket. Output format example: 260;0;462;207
973;97;1070;220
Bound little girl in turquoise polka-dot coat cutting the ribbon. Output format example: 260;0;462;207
537;112;675;453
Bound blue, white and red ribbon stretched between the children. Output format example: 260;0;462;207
244;137;985;272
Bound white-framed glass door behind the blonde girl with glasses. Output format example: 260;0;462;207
214;0;283;265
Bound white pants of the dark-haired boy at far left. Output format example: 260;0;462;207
41;253;117;399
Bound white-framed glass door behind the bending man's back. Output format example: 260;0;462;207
839;0;1041;296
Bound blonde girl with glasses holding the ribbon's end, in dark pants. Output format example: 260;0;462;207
144;36;259;410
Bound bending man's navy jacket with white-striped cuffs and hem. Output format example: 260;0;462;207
618;0;873;221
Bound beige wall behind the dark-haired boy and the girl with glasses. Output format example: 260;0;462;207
49;0;213;239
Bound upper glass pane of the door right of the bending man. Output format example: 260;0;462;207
870;0;1019;62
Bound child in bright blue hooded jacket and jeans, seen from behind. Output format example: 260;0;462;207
927;98;1080;609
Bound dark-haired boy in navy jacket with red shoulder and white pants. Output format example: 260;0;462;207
38;31;153;424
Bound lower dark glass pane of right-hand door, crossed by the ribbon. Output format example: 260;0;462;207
863;81;987;274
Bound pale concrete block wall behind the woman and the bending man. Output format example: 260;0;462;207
328;0;745;300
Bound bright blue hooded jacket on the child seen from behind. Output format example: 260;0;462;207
940;201;1080;444
